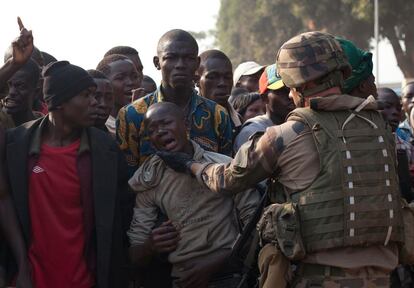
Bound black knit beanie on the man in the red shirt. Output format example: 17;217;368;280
42;61;96;111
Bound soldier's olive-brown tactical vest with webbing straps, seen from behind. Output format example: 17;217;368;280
289;108;403;253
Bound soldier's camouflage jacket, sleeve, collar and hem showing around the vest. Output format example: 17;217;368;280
196;95;398;271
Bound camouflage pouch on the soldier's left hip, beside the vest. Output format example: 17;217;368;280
257;203;306;261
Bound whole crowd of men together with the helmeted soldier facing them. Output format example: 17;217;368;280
0;18;414;288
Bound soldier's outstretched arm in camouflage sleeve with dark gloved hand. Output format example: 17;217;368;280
157;121;305;194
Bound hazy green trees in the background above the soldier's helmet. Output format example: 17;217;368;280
216;0;414;78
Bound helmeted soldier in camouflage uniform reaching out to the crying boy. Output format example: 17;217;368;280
161;32;405;287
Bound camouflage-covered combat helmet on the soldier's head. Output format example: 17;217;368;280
276;31;351;96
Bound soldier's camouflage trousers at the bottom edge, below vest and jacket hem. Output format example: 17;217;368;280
292;265;390;288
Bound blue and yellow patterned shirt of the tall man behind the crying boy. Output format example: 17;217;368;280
116;88;232;175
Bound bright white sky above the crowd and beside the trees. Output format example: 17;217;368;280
0;0;402;83
